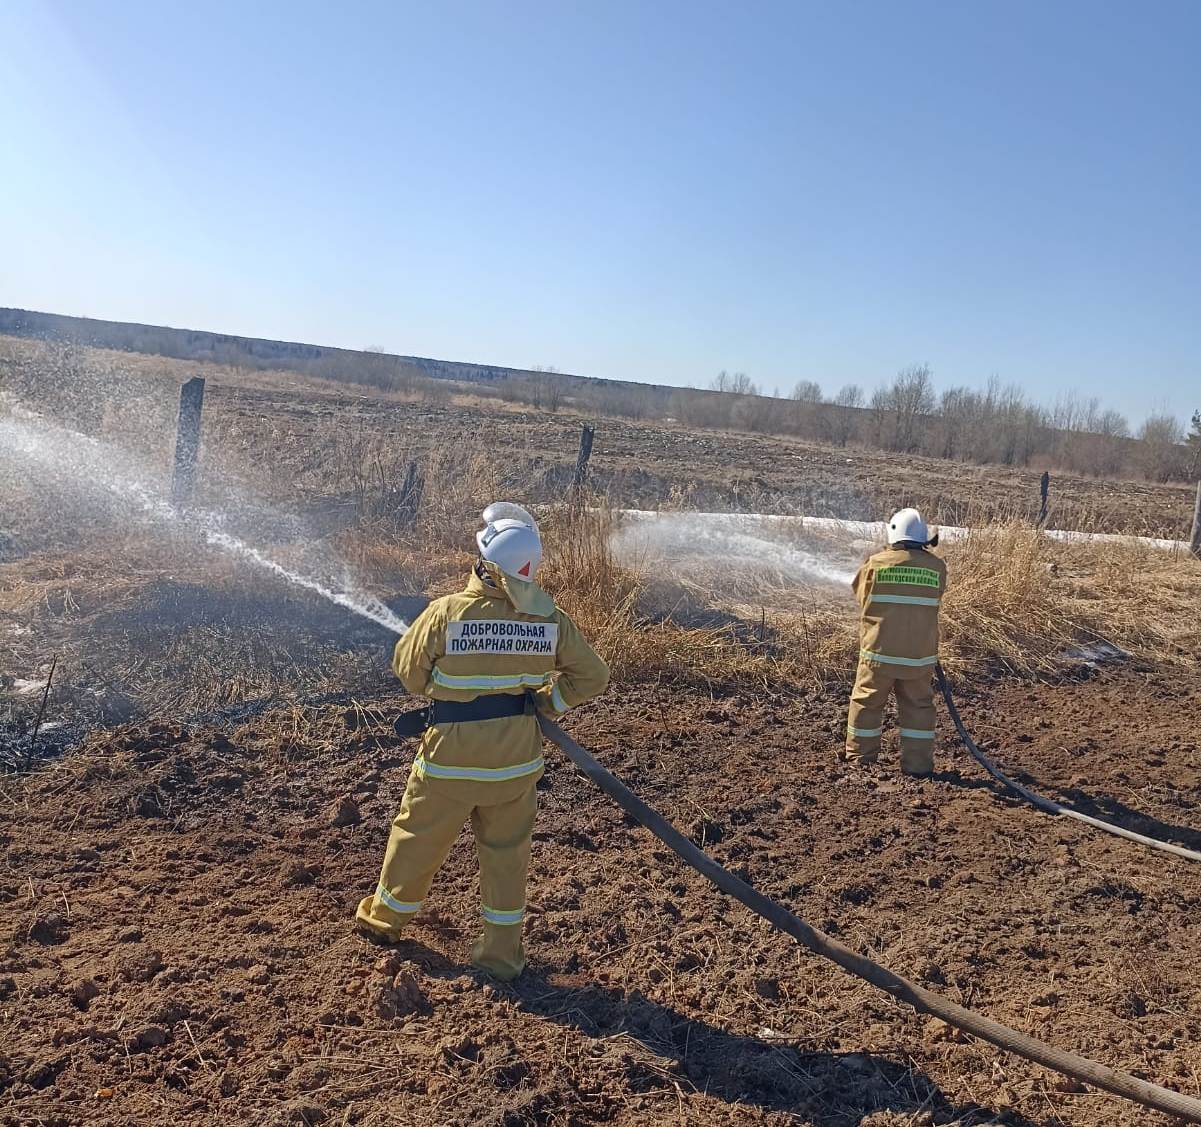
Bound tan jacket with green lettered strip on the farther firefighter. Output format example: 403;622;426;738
852;548;946;678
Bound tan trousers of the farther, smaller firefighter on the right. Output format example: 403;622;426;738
847;660;934;775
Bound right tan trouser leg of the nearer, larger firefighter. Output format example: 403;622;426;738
471;786;538;978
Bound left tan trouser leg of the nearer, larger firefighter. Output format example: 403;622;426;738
354;775;471;937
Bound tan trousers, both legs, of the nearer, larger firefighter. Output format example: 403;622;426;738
354;771;540;979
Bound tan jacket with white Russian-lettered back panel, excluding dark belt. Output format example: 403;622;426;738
392;573;609;783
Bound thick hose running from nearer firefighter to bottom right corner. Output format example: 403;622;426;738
538;716;1201;1123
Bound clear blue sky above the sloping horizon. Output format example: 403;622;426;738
0;0;1201;423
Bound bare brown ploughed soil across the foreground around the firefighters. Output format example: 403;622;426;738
0;670;1201;1127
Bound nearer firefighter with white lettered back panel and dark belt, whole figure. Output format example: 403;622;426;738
355;501;609;979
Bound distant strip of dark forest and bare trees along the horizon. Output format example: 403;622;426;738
0;309;1201;482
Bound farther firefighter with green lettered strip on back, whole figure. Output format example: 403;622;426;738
847;508;946;776
